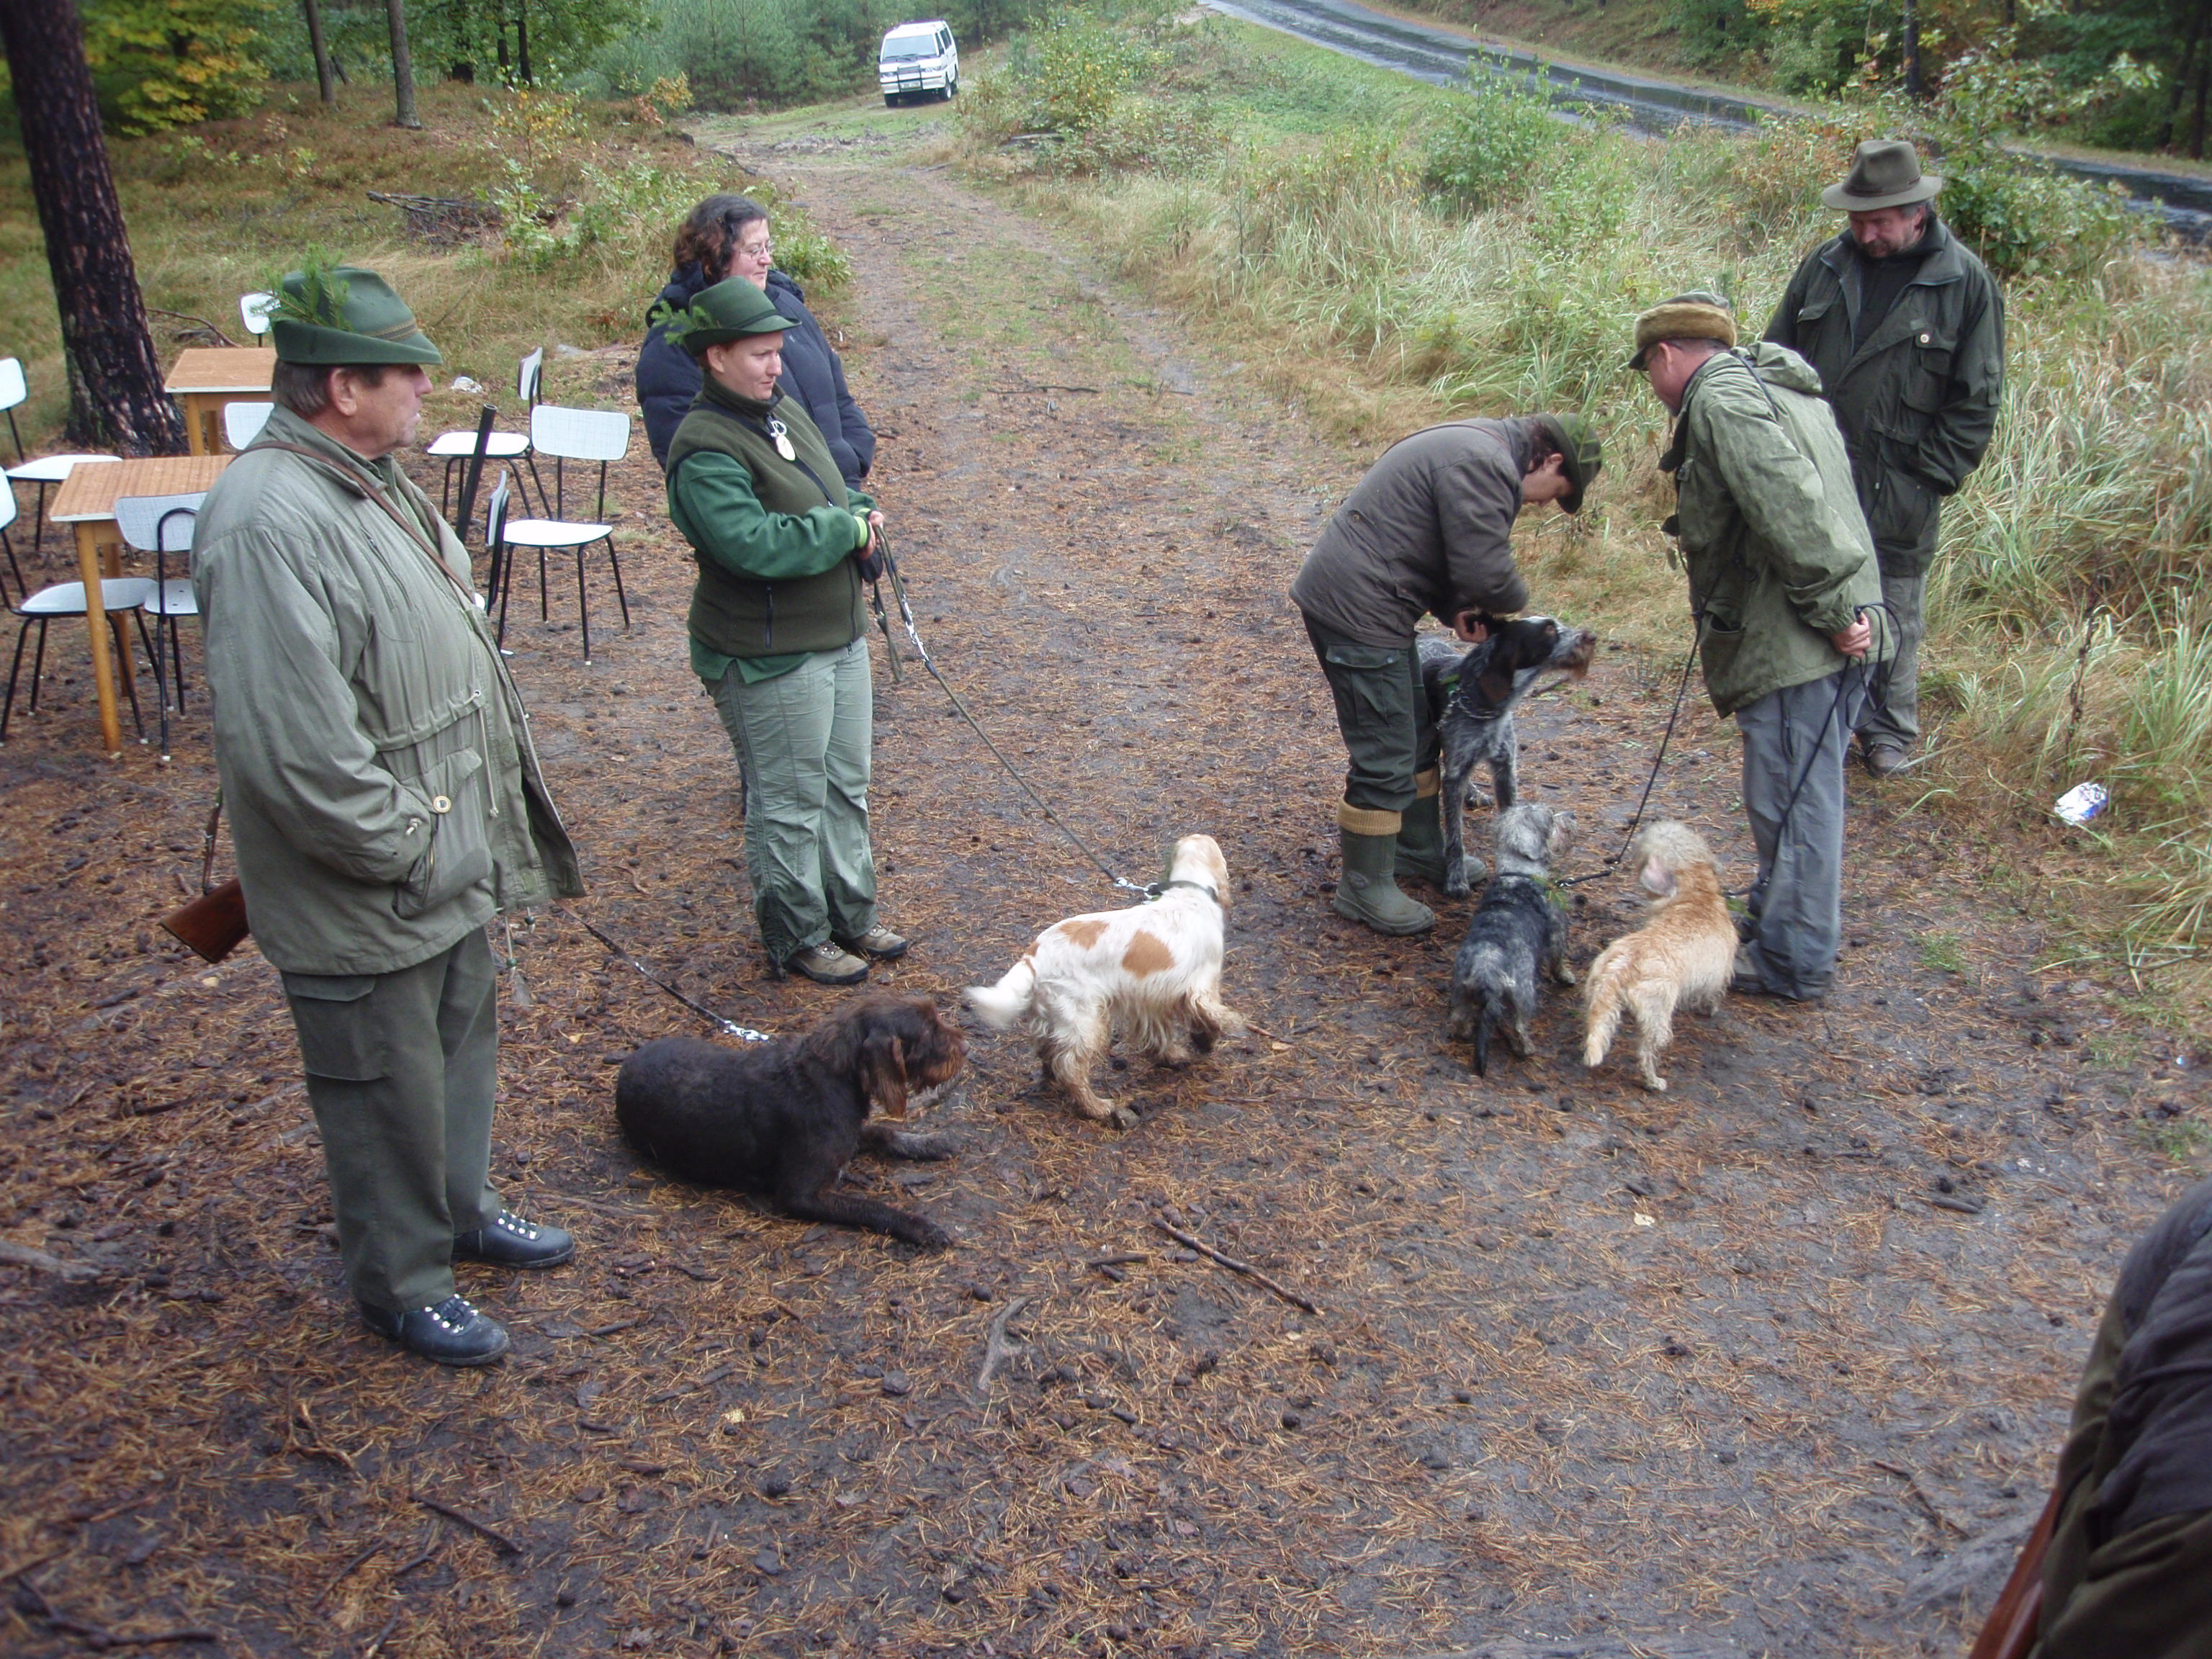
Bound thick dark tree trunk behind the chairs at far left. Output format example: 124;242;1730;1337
0;0;184;456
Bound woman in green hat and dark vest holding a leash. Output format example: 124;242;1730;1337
659;276;907;984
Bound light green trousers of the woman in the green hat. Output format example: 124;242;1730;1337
708;635;876;962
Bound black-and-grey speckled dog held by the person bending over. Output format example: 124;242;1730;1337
1420;615;1597;898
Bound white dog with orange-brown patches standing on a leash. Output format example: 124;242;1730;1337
964;836;1246;1128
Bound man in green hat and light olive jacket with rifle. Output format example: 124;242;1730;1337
192;266;582;1364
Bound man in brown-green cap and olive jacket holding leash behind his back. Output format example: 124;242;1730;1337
1628;295;1889;1002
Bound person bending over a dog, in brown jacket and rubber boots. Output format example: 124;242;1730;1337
1290;413;1604;933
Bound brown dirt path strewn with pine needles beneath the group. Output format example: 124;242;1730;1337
0;133;2201;1659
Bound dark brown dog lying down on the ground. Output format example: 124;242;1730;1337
615;991;966;1248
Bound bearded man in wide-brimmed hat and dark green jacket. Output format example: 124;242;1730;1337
1765;140;2004;776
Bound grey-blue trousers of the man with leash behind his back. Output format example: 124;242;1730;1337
1737;666;1865;1000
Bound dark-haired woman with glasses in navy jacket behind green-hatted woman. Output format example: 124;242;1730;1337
637;197;876;489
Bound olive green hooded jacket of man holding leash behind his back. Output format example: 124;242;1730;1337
1659;345;1889;714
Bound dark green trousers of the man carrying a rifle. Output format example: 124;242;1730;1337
283;929;500;1312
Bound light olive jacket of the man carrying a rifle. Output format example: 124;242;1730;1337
192;409;584;976
